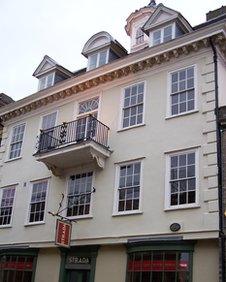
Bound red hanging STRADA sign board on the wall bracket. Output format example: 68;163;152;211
55;219;72;248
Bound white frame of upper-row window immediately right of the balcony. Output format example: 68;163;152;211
118;80;147;131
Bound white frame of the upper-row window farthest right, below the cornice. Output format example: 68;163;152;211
166;64;198;119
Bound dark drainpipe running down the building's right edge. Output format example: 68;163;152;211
210;38;226;282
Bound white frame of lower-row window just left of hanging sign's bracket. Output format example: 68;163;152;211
24;178;50;226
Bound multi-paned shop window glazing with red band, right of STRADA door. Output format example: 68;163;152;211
127;251;192;282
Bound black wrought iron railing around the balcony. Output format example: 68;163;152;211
36;116;109;154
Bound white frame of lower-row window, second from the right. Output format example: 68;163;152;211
112;158;144;216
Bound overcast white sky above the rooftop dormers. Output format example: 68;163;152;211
0;0;226;100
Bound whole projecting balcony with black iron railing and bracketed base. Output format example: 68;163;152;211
35;116;110;176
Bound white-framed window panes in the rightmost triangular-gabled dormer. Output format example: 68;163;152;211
152;25;175;46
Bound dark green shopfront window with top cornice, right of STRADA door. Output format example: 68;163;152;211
126;240;193;282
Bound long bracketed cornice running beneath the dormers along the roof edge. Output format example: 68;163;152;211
0;24;226;122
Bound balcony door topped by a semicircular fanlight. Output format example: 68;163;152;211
76;97;99;141
